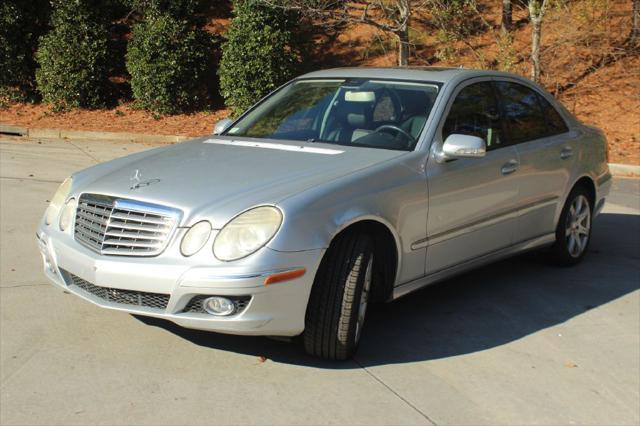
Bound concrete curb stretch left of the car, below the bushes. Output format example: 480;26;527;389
0;124;195;143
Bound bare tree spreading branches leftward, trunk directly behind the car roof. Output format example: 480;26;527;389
259;0;418;66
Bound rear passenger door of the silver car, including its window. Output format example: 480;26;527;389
495;80;577;243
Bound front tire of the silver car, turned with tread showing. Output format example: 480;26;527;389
303;232;374;360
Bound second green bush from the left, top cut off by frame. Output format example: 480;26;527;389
36;0;112;110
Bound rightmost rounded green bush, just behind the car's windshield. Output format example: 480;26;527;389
218;0;306;115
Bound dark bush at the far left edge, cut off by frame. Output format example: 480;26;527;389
0;0;50;100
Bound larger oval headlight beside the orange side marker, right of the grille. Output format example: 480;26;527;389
213;206;282;260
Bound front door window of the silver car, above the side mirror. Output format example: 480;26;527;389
442;82;503;150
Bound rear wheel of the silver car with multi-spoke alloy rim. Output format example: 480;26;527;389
551;186;593;266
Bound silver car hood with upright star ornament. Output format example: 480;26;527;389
74;137;406;228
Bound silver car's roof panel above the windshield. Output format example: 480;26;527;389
298;67;521;83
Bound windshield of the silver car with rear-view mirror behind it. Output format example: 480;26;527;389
224;79;439;151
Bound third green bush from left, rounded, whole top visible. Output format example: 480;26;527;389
126;13;215;114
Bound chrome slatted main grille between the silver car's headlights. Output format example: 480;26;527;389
74;194;180;256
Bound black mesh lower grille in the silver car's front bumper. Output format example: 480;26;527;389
62;271;169;311
